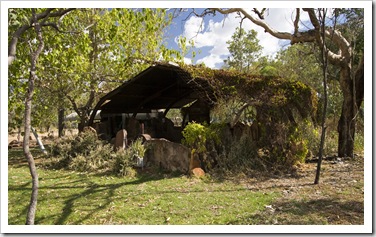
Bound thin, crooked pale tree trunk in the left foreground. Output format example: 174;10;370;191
23;9;44;225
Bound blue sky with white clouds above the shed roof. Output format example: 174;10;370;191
166;8;308;68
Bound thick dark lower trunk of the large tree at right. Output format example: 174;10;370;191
338;60;364;157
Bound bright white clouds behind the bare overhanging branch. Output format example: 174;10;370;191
178;8;308;67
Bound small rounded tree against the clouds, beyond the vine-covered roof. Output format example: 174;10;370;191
224;27;262;73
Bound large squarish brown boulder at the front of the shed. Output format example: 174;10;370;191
144;138;191;173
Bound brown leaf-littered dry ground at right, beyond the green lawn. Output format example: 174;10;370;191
242;156;366;225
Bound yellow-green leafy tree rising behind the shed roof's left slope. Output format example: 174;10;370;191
37;9;176;131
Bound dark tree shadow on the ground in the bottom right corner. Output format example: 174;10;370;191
229;198;364;225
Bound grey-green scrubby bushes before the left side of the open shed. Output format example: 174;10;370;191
50;131;150;177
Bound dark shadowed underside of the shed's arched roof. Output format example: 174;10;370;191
91;64;216;118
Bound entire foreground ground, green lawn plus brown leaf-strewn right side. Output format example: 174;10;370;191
8;148;364;225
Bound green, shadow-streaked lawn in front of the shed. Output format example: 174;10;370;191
8;149;279;225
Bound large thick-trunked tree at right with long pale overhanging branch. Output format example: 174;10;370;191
202;8;364;157
